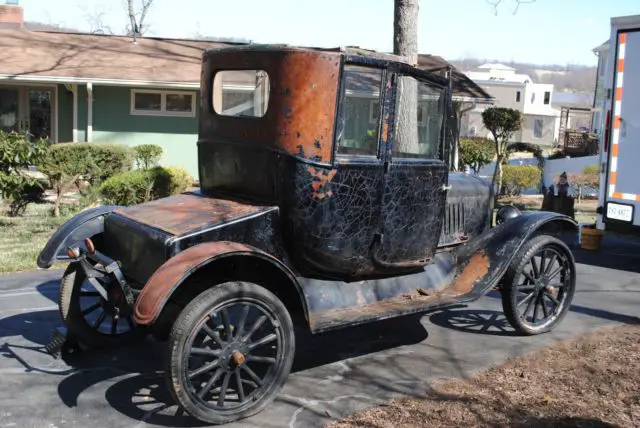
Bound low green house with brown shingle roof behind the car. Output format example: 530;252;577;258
0;4;491;178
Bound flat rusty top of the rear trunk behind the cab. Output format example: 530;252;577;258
115;193;273;236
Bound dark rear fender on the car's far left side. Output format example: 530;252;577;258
36;205;120;269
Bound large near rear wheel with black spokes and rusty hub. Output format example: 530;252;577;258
166;282;295;424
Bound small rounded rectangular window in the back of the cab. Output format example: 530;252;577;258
212;70;270;117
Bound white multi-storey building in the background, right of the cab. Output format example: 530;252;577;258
460;64;560;146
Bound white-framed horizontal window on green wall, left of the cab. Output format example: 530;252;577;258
131;89;196;117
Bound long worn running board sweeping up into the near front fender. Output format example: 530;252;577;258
300;212;575;333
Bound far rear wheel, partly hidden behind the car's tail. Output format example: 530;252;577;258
59;262;147;348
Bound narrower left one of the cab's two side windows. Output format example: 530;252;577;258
337;65;382;156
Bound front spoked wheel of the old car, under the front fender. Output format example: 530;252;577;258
500;235;576;336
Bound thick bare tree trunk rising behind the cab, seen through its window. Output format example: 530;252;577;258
393;0;420;153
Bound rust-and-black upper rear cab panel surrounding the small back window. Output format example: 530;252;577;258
199;48;342;164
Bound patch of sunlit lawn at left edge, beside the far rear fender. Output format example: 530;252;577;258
0;203;76;274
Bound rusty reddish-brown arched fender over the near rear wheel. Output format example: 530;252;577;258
134;241;262;325
